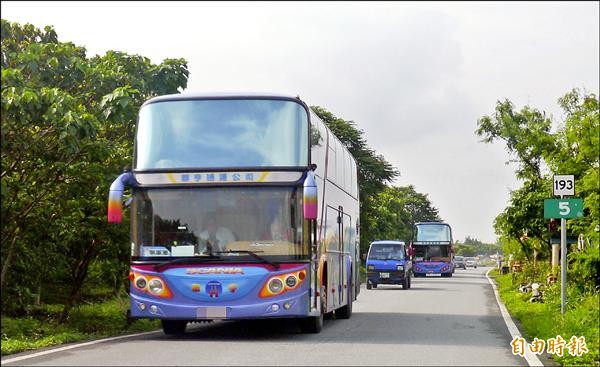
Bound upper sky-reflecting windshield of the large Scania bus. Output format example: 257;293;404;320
135;99;308;170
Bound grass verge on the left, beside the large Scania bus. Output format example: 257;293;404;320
1;297;160;356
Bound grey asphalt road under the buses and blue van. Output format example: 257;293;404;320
2;267;527;366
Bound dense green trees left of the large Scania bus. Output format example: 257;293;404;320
1;19;188;317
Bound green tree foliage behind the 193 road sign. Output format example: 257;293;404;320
476;89;600;258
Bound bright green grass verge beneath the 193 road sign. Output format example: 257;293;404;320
490;270;600;366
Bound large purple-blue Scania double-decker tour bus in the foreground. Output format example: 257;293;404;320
108;94;360;334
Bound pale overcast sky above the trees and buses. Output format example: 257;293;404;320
1;1;600;242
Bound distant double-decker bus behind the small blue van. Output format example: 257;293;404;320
411;222;454;277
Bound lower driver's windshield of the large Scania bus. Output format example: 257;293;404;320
132;187;308;260
